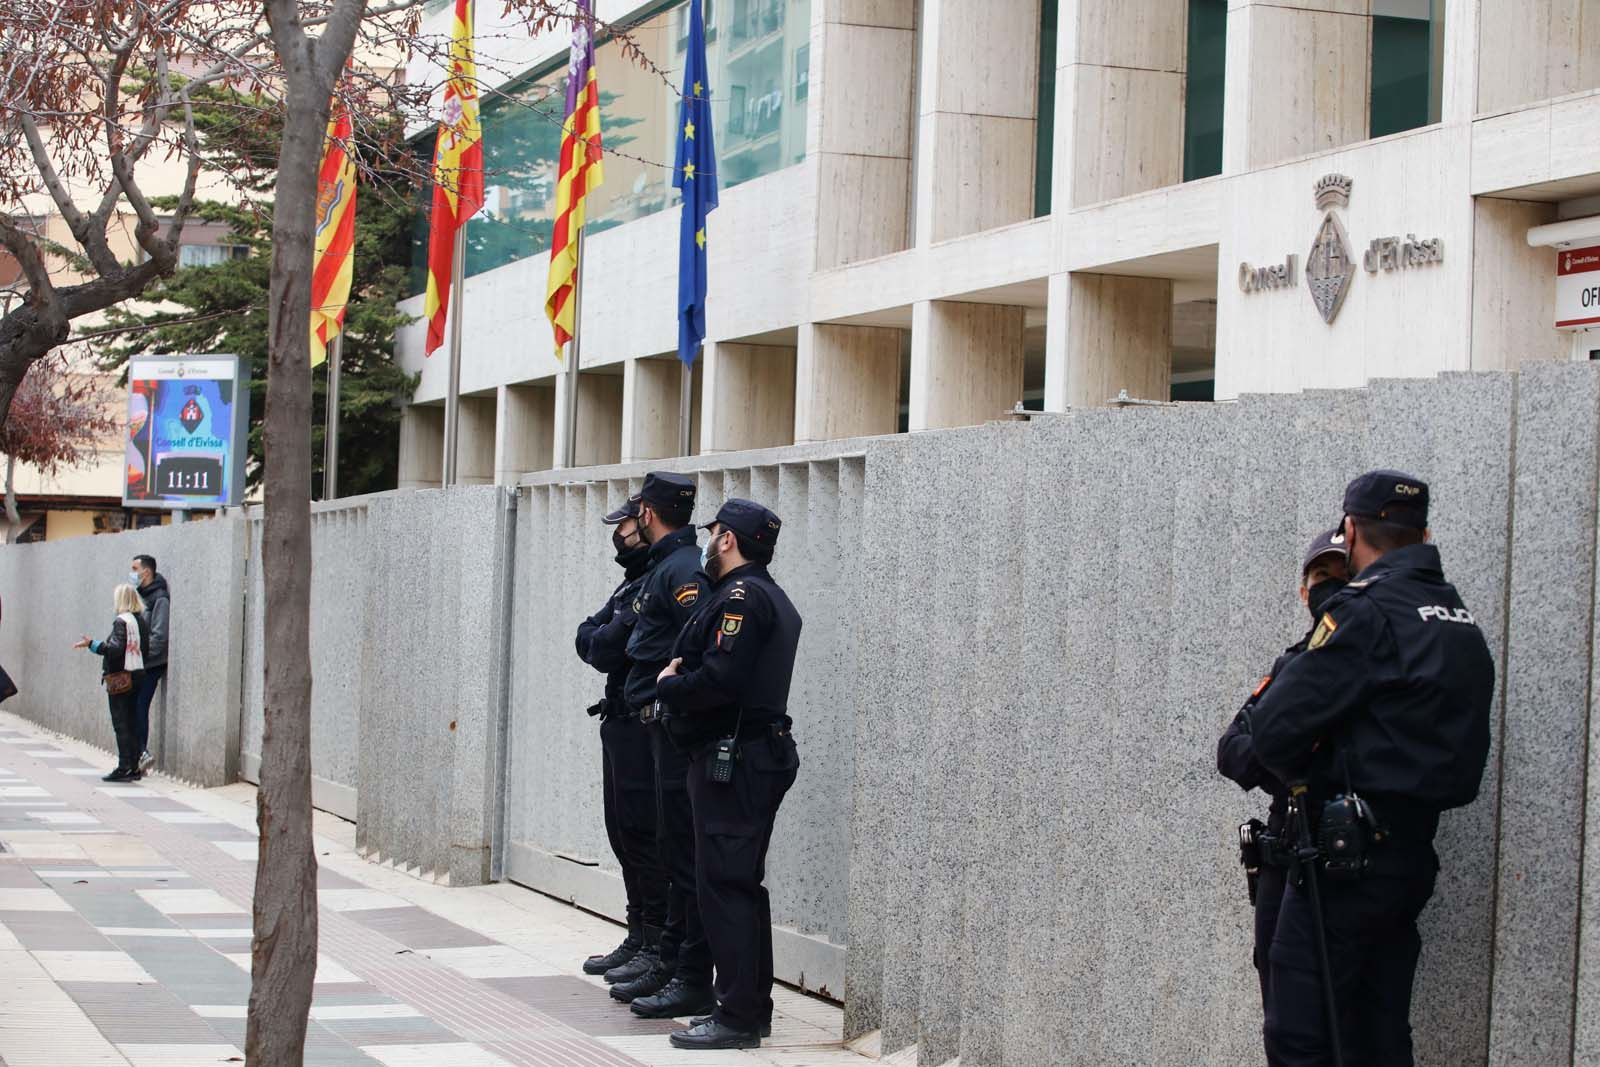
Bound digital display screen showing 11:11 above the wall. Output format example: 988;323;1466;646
123;355;250;509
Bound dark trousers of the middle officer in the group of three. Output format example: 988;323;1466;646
645;726;710;987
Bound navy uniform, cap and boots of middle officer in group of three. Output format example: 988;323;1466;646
613;472;710;1014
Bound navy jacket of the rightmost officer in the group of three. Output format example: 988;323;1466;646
659;563;800;744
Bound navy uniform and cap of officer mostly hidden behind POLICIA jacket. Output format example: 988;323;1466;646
1216;530;1346;1009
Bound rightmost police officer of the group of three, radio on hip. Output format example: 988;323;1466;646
658;499;800;1048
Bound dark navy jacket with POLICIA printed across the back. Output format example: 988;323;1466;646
1248;544;1494;838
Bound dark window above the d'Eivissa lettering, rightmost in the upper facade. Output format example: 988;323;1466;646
1370;0;1445;138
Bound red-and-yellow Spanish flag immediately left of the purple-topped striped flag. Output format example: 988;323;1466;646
422;0;483;355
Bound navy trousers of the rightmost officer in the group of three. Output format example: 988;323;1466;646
688;733;800;1030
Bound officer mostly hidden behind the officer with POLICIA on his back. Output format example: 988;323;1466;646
1216;528;1350;1009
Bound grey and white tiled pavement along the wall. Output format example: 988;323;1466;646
0;713;867;1067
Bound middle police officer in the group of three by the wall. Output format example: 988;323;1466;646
606;470;715;1019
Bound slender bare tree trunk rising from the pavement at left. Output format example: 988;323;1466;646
245;29;328;1067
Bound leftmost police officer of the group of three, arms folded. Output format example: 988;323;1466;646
578;499;667;974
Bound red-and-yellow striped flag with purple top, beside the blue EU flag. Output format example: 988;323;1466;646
544;0;605;358
